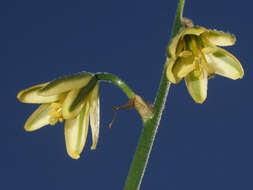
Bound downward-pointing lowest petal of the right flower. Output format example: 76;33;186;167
185;70;208;104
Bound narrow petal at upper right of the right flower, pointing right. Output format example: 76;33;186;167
203;30;236;46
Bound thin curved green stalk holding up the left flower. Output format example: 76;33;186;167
95;73;135;99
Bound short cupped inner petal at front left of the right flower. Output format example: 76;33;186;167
172;56;195;79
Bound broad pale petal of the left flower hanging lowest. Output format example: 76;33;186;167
64;103;89;159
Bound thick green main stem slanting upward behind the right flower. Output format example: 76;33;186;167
124;0;185;190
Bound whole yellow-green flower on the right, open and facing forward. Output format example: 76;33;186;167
166;27;244;103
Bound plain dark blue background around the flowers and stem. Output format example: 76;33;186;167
0;0;253;190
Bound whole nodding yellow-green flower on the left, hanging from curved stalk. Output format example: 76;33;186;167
17;72;99;159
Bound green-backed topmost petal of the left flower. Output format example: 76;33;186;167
39;72;93;96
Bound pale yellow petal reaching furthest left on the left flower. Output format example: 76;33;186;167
17;83;62;104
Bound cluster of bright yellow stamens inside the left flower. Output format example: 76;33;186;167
48;102;64;125
